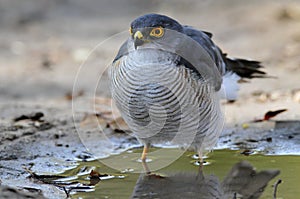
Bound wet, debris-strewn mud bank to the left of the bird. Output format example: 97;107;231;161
0;102;137;198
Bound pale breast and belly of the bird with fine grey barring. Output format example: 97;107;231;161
110;49;222;150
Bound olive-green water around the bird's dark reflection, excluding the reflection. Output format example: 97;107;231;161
59;149;300;199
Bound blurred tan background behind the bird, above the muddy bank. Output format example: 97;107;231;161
0;0;300;107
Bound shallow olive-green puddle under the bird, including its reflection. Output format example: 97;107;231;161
57;149;300;199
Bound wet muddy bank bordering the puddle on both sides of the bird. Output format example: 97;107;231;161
0;103;300;198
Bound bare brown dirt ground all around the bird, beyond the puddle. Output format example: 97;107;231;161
0;0;300;198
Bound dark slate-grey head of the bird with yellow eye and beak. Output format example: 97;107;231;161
130;14;183;48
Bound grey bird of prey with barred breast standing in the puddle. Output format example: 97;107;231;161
110;14;265;166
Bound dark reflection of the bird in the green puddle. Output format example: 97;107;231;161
132;161;279;199
